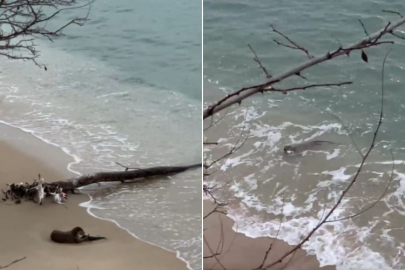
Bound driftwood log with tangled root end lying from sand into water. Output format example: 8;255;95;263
1;163;202;204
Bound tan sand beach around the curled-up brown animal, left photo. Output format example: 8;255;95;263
0;125;187;270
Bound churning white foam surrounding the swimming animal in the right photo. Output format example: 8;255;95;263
207;99;405;270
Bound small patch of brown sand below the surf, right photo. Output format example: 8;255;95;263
203;201;336;270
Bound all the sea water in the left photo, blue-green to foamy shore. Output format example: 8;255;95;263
0;0;201;269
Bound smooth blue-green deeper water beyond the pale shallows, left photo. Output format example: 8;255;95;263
49;0;202;100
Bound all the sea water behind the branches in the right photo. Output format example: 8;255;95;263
203;0;405;270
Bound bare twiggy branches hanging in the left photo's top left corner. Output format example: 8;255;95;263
0;0;94;67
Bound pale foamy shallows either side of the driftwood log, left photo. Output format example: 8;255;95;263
0;40;201;269
